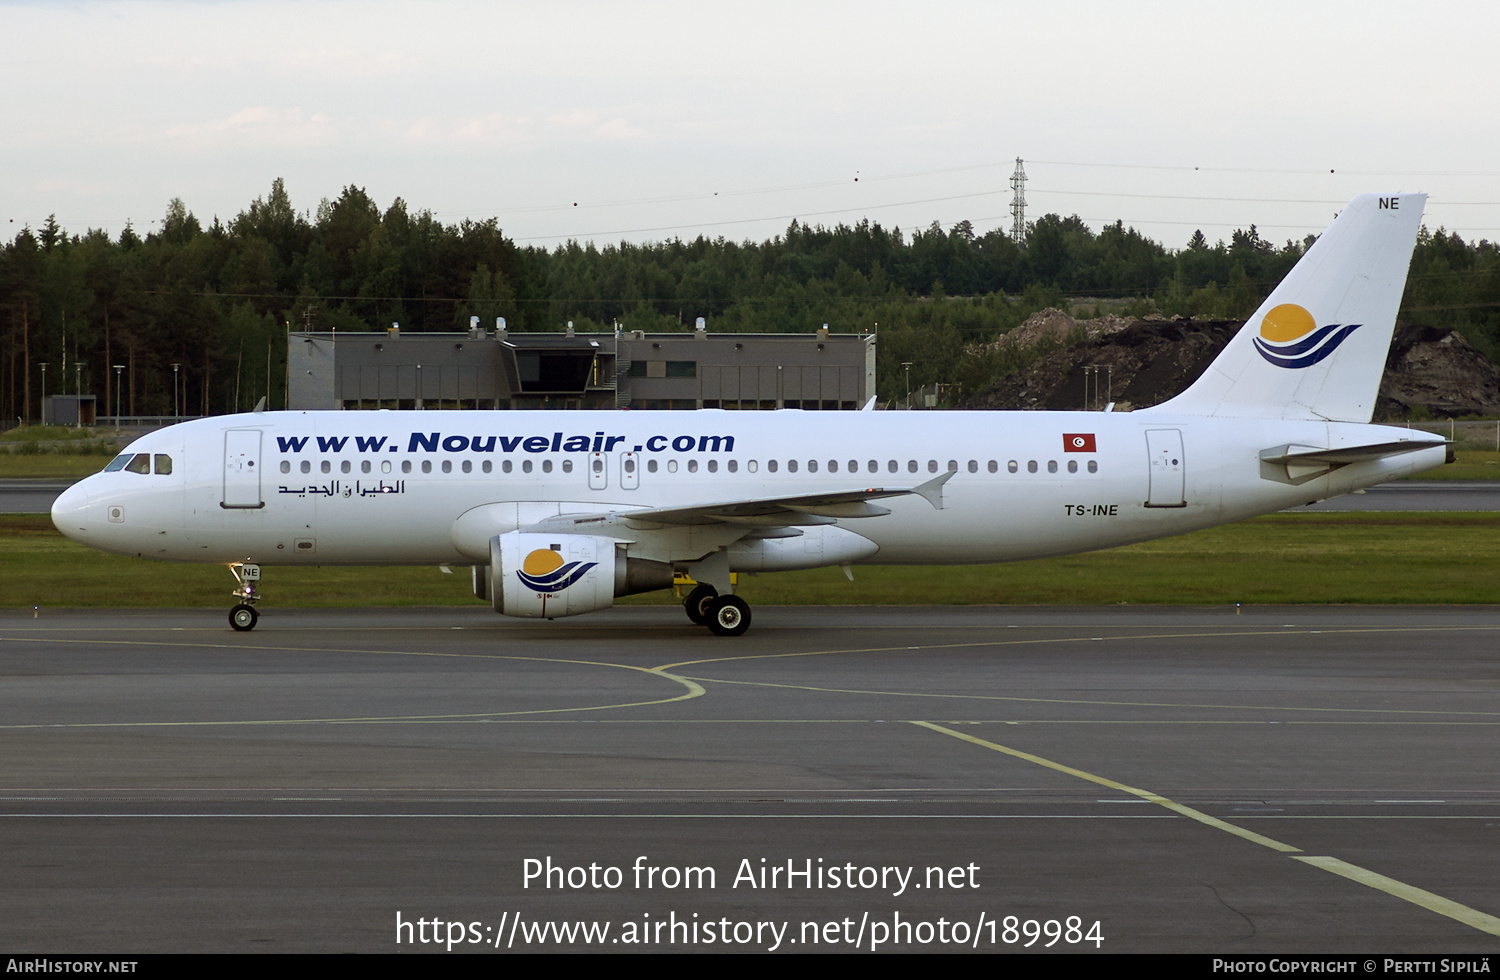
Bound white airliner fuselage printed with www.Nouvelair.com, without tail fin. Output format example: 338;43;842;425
53;410;1445;566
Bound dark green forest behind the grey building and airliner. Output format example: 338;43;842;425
0;180;1500;426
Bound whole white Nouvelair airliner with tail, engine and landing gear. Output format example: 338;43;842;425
53;194;1446;636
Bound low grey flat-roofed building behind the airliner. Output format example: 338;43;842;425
287;320;875;410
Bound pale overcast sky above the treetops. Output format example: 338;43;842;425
0;0;1500;248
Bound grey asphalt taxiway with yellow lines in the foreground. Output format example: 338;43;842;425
0;606;1500;953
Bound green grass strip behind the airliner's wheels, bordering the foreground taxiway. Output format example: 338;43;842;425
0;512;1500;608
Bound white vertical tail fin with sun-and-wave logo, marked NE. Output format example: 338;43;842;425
1152;194;1427;422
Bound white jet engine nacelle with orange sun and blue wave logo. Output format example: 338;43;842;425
489;531;672;620
